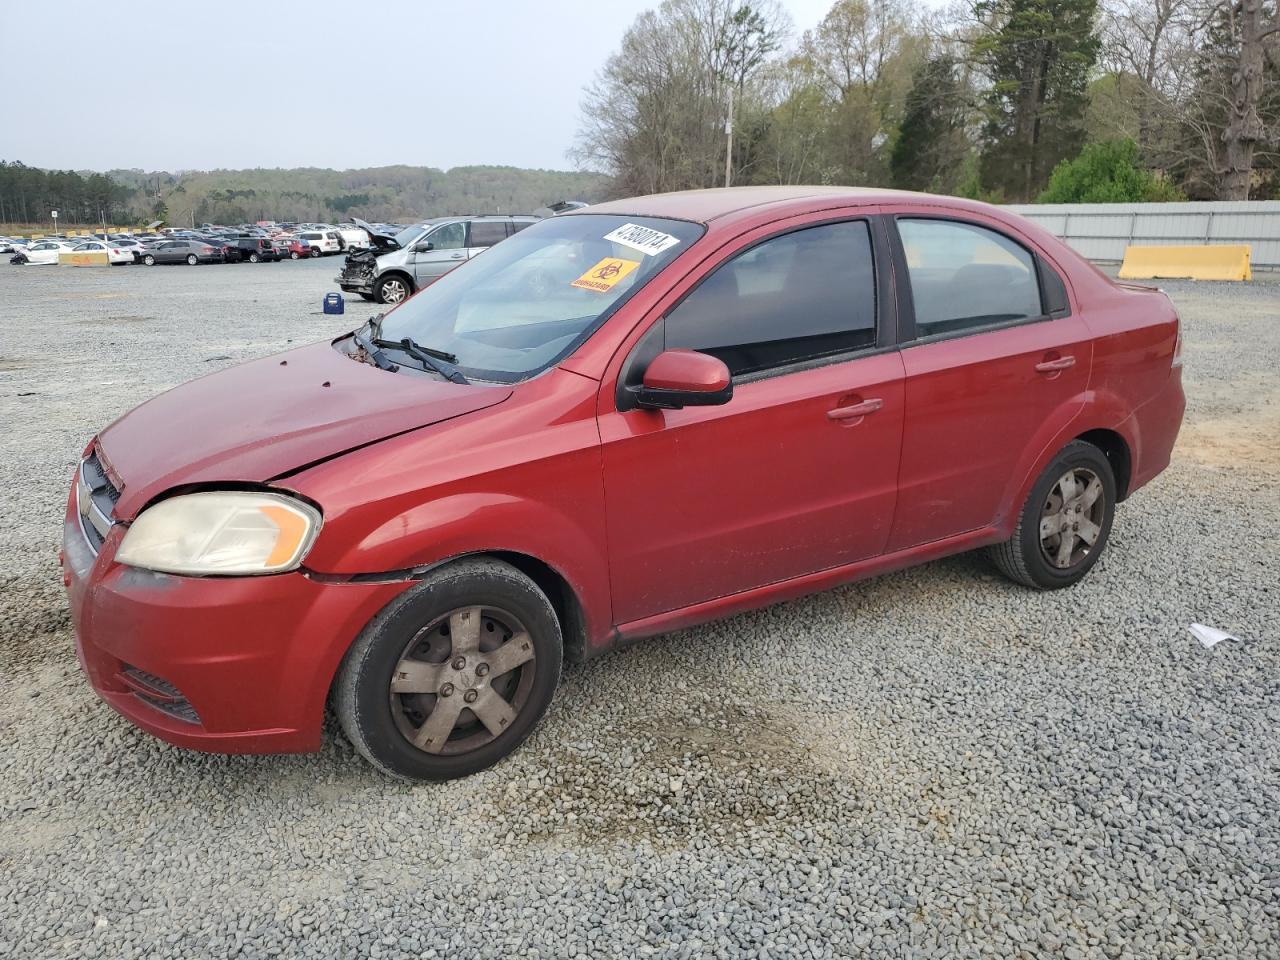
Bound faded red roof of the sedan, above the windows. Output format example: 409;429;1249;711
561;186;942;223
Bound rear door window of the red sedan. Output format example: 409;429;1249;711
897;218;1044;337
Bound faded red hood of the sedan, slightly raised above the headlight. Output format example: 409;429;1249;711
97;342;512;520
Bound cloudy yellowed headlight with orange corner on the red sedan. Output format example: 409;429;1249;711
115;490;320;576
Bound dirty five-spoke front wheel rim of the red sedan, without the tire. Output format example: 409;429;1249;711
389;607;535;755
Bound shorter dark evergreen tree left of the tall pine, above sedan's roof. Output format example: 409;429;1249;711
890;54;969;193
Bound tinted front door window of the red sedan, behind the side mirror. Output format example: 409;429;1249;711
666;220;876;376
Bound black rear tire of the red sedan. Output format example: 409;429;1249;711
988;440;1116;590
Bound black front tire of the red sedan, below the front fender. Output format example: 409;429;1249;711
333;557;563;781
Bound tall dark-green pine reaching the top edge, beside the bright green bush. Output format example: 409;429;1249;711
974;0;1100;201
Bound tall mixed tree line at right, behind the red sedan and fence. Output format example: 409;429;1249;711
575;0;1280;202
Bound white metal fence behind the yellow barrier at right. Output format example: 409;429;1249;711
1006;200;1280;268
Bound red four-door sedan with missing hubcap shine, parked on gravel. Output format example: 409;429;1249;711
64;187;1184;780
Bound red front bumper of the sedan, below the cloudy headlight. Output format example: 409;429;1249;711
63;492;410;753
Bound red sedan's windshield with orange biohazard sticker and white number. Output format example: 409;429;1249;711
380;214;703;383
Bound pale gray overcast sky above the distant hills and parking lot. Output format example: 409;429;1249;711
0;0;832;170
